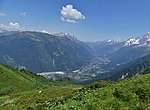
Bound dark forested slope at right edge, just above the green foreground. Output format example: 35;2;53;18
109;55;150;80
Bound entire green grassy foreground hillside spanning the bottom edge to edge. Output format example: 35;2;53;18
0;66;150;110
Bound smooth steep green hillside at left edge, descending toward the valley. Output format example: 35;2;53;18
0;65;50;96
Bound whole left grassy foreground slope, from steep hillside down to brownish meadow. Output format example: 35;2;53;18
0;65;79;110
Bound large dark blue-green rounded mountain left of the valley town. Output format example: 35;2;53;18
0;31;92;72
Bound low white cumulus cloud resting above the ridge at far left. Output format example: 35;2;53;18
0;22;24;31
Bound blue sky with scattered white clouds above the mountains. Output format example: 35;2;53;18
0;0;150;41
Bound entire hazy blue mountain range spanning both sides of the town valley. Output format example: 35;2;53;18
0;31;150;82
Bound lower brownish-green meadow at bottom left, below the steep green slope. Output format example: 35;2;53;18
0;85;78;110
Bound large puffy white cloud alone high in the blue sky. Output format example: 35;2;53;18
60;5;85;23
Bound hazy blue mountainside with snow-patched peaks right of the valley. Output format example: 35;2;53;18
87;33;150;67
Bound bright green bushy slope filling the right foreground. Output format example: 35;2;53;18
48;74;150;110
